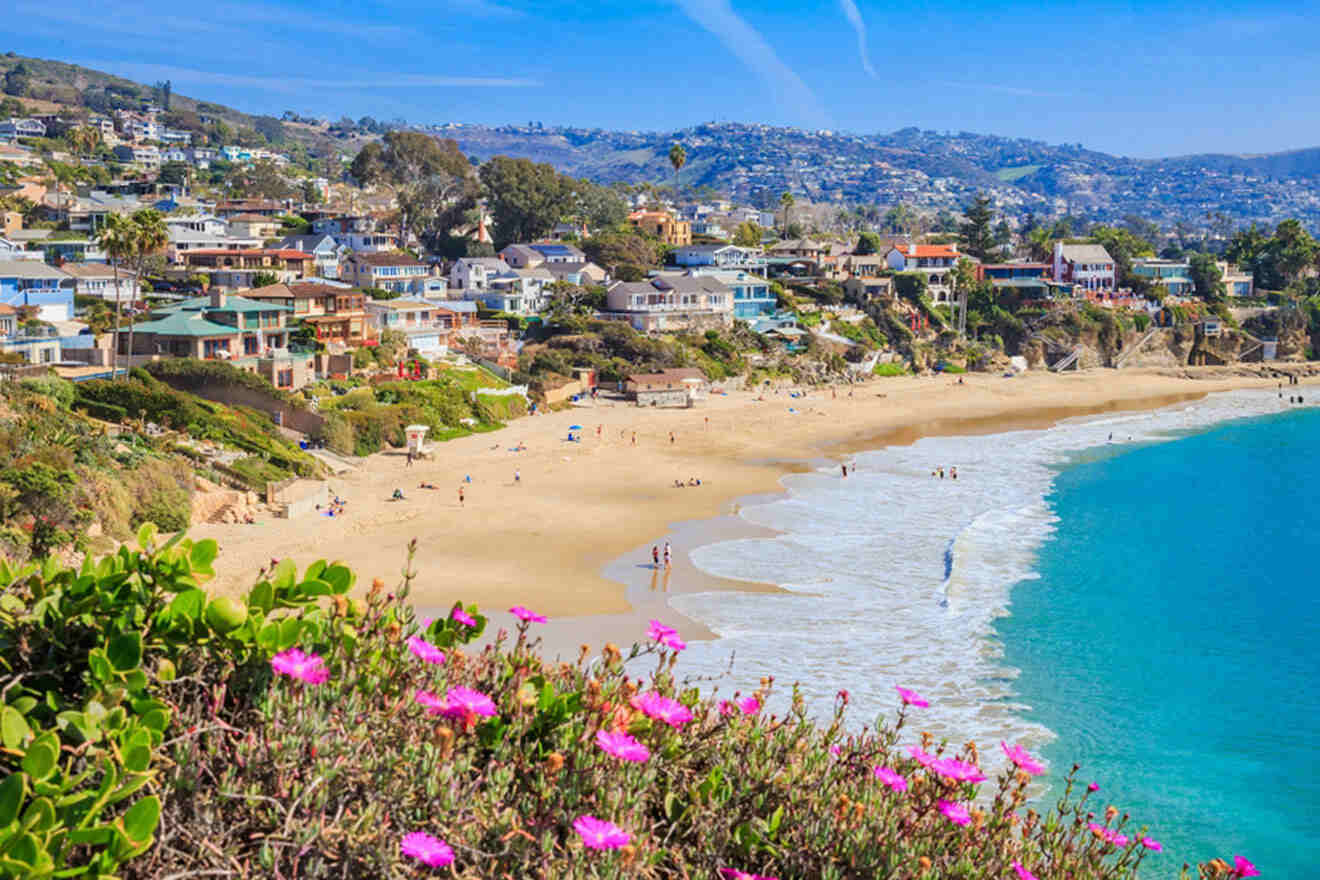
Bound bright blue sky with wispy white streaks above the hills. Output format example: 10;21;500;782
10;0;1320;156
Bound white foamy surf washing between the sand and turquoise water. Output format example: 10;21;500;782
654;392;1286;767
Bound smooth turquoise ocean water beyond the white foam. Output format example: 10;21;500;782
997;410;1320;877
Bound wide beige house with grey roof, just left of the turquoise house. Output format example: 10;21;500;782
601;274;734;332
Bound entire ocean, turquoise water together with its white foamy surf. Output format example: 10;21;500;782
672;392;1320;877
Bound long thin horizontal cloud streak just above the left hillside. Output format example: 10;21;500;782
86;61;541;94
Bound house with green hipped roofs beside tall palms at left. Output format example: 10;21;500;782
119;292;292;360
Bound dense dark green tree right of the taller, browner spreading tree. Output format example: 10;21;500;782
480;156;576;247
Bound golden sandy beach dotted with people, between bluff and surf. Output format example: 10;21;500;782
190;368;1298;646
